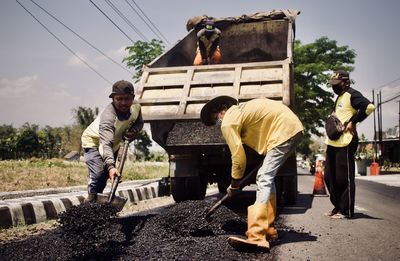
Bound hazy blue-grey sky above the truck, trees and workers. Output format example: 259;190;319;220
0;0;400;137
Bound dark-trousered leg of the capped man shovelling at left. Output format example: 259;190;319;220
84;148;108;194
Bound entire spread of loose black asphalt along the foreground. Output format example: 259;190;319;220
0;201;273;260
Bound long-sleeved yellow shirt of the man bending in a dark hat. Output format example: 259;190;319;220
221;98;303;179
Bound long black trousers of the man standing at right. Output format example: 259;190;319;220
324;135;358;217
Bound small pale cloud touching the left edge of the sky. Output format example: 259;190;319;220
0;74;38;98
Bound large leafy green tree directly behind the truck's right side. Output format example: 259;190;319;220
294;37;356;155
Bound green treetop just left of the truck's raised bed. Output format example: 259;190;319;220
122;39;165;81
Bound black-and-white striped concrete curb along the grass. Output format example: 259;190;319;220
0;182;163;228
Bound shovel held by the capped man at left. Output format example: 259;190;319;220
96;140;129;212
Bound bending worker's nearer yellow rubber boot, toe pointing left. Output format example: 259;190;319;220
228;204;269;252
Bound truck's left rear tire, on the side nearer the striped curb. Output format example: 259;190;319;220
171;176;207;202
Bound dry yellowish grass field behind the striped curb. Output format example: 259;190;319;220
0;159;168;192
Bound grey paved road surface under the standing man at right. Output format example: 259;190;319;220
275;169;400;260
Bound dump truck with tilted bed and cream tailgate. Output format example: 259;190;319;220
135;10;299;204
